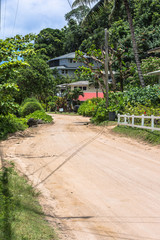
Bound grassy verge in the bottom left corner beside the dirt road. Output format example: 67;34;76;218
0;161;58;240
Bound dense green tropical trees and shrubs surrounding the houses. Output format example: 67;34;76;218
0;0;160;137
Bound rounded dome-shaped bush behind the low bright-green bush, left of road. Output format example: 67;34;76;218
20;102;44;117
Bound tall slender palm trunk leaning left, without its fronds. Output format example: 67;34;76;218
123;0;145;87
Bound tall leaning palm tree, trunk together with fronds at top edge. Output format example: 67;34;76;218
72;0;145;87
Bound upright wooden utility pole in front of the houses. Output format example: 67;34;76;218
104;28;109;108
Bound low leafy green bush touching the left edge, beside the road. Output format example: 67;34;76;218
0;114;28;139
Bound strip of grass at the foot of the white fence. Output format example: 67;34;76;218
113;126;160;145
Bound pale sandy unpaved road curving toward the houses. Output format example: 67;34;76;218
2;115;160;240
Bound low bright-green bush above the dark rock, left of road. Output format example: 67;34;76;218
25;110;53;123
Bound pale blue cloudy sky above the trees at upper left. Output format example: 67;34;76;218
0;0;73;39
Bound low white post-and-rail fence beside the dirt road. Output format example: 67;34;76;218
118;114;160;131
